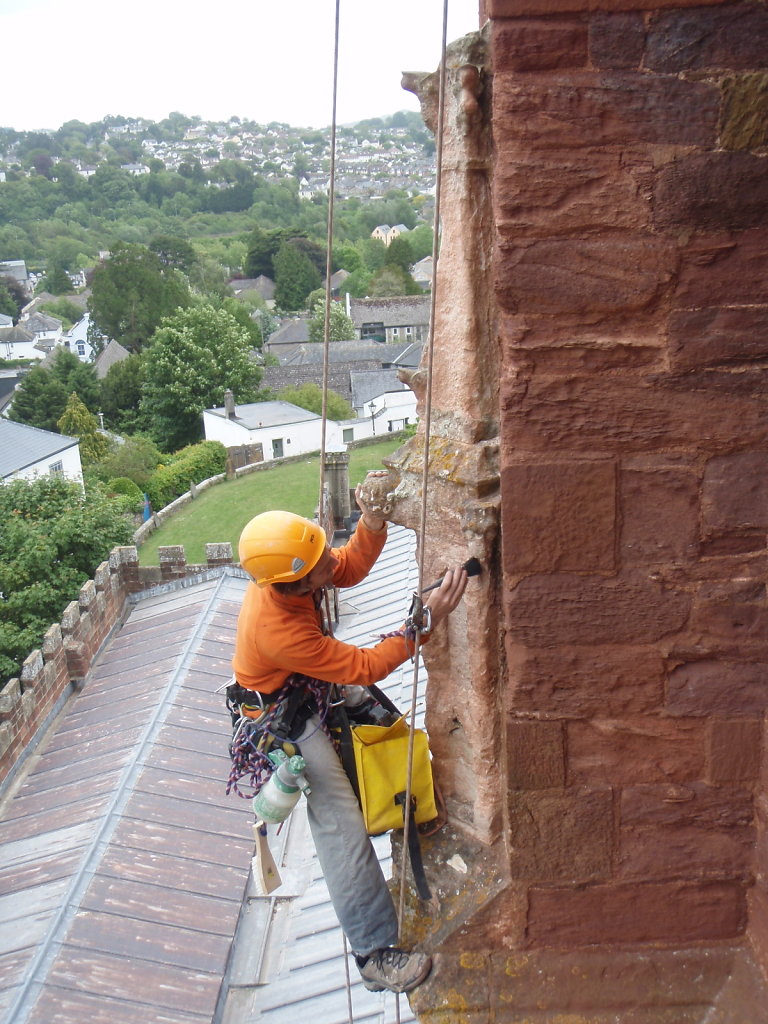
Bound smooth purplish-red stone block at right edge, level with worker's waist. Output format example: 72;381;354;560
666;658;768;716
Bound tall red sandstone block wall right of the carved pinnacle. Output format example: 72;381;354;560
493;0;768;967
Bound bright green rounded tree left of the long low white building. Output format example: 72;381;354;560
141;304;261;451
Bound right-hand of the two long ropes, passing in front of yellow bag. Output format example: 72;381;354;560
397;0;449;931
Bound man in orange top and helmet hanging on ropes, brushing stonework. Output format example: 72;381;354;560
227;485;467;992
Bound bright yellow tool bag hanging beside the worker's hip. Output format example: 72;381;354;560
351;716;437;836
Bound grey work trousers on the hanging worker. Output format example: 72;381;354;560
296;715;397;956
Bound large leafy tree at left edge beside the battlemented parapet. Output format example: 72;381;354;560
0;476;134;680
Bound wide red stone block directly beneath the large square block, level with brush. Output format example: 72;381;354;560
506;571;690;647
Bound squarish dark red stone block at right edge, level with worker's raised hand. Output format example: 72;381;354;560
701;456;768;531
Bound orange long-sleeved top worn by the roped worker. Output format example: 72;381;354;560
232;519;421;693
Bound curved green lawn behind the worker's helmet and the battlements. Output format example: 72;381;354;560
139;435;411;565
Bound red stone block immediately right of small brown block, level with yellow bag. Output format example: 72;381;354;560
566;718;706;785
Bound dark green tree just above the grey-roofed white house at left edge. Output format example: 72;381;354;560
8;348;99;433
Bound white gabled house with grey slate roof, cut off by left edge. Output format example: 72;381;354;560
0;419;83;486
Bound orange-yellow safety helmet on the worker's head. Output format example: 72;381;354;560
238;512;326;587
